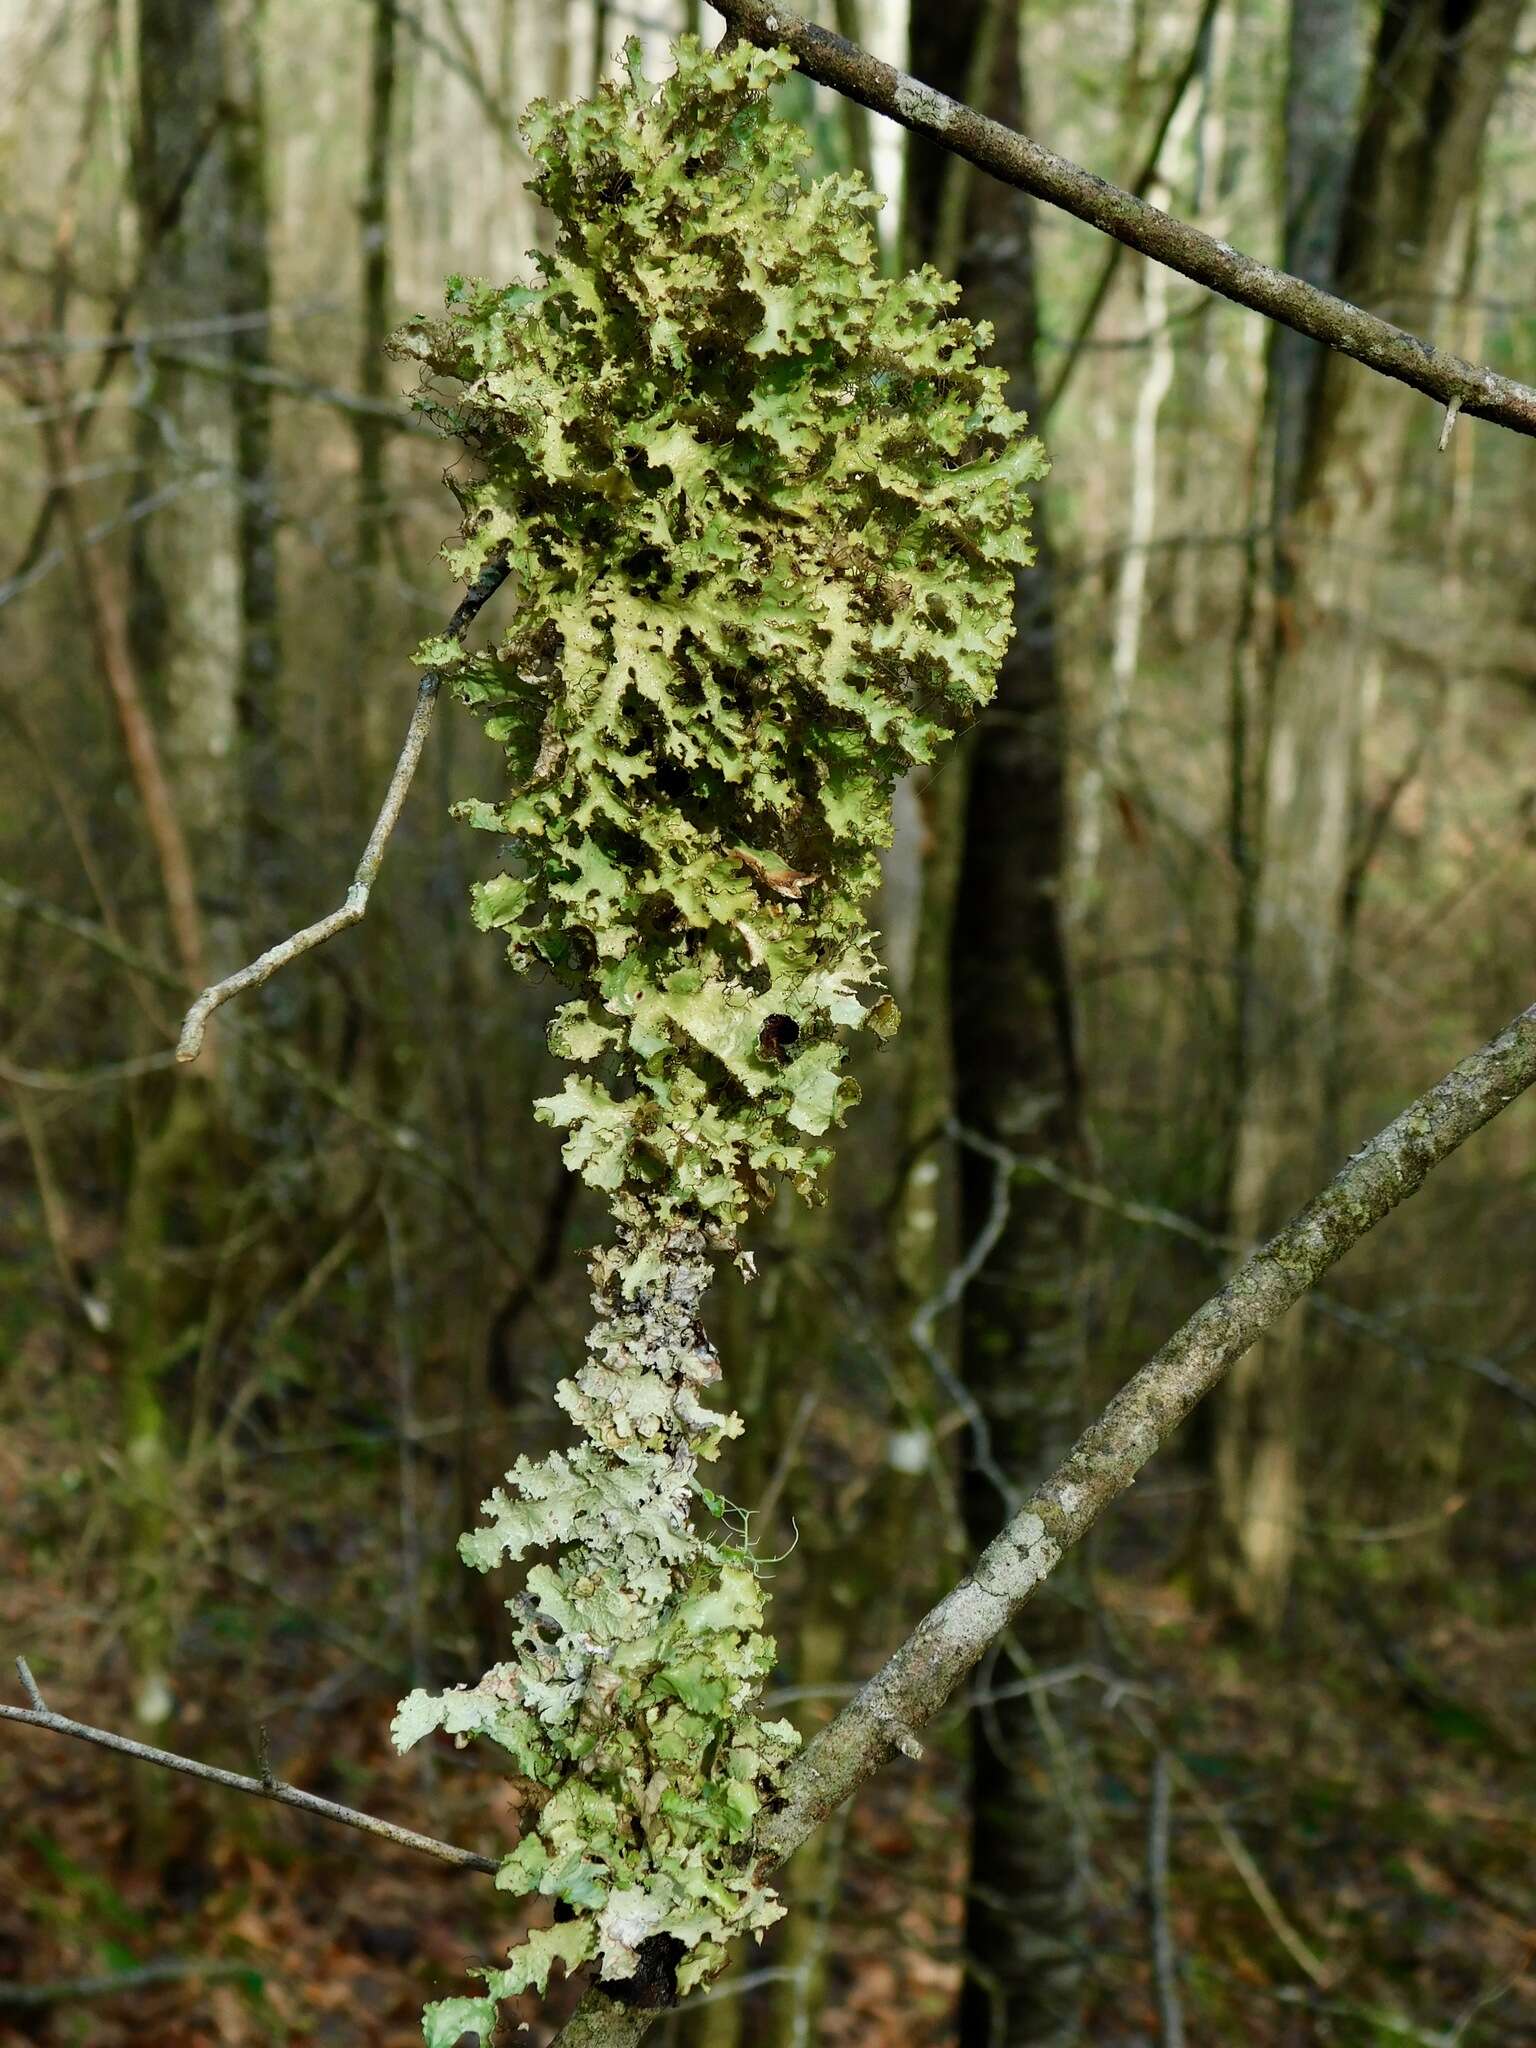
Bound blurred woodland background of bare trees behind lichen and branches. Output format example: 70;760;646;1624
0;0;1536;2048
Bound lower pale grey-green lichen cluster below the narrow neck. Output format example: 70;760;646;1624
393;1231;797;2015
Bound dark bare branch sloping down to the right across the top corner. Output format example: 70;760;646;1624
713;0;1536;434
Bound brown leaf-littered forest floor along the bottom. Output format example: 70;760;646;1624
0;1269;1536;2048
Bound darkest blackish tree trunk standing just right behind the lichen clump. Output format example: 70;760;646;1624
909;0;1083;2048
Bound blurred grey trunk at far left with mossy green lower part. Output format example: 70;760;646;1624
117;0;279;1810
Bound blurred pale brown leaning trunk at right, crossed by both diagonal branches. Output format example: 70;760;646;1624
1212;0;1522;1628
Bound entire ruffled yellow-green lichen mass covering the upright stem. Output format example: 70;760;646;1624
393;37;1044;2044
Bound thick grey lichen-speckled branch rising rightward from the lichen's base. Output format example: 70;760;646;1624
557;1006;1536;2048
